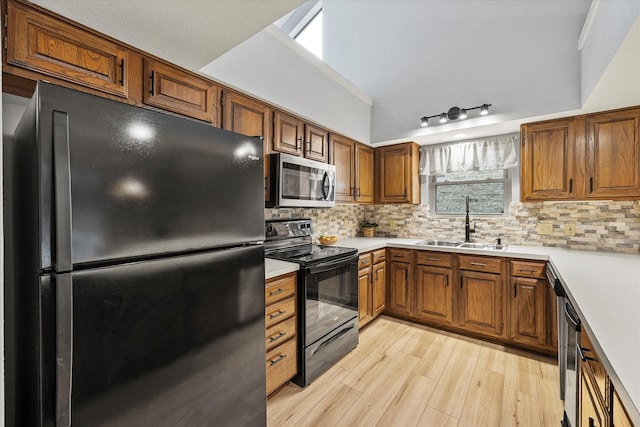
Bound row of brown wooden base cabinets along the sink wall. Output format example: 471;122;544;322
385;248;557;354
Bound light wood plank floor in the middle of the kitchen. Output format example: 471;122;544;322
267;316;562;427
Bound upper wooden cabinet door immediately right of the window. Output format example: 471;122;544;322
520;120;578;201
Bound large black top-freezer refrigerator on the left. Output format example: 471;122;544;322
5;82;266;427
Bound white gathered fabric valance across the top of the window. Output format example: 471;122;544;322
420;133;520;175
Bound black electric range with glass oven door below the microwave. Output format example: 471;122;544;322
265;219;358;387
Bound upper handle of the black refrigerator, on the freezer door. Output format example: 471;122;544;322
53;111;72;272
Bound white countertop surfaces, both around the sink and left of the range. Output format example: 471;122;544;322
266;237;640;424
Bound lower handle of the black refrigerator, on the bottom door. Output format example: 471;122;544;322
56;273;73;427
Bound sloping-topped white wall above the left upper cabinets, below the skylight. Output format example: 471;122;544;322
200;26;372;143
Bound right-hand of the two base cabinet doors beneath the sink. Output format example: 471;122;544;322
460;270;505;337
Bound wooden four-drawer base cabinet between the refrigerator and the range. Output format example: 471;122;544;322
265;273;298;395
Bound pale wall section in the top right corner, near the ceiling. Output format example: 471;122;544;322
580;0;640;103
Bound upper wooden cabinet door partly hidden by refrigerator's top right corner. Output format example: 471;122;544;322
222;91;271;200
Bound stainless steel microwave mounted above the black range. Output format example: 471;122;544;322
265;153;336;208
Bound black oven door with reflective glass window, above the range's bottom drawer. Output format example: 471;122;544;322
302;254;358;347
